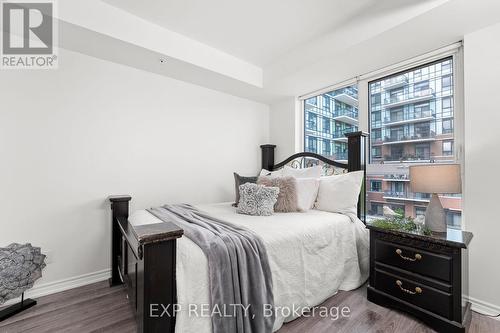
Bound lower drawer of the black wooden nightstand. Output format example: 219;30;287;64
374;269;453;319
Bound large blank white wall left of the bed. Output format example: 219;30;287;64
0;49;269;290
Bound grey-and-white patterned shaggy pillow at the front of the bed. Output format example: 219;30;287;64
236;183;280;216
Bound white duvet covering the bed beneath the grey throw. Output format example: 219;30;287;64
129;203;369;333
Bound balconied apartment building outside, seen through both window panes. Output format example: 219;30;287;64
304;57;462;227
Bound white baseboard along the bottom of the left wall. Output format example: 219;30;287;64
2;269;111;306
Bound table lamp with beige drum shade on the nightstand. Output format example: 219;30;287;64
410;164;462;232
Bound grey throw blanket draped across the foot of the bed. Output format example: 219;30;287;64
148;204;274;333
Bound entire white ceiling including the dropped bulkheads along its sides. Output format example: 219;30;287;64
58;0;500;104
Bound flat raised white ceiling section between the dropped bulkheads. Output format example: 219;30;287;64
104;0;435;66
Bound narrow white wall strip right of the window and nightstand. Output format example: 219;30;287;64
464;24;500;314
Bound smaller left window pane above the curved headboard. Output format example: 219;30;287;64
304;85;358;159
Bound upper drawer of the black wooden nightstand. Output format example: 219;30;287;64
375;239;452;282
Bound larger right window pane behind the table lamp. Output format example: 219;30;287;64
365;57;461;226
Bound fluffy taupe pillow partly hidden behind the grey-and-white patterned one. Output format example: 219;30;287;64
257;176;299;213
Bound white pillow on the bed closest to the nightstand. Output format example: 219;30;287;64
316;171;364;215
